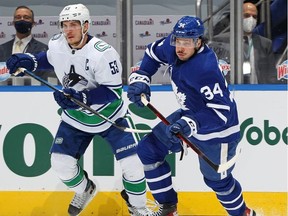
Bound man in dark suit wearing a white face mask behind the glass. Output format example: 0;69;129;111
210;2;279;84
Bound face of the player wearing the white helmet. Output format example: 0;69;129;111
61;20;82;47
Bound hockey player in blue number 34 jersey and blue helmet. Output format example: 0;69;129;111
127;16;256;216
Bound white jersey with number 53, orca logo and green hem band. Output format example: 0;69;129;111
47;34;126;133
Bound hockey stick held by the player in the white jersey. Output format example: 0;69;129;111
15;68;151;133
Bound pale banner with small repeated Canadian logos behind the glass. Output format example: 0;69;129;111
0;15;186;84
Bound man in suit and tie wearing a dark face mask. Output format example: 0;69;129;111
0;6;56;85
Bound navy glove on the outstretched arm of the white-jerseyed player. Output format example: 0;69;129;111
6;53;38;76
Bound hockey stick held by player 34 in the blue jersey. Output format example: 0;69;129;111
141;94;240;173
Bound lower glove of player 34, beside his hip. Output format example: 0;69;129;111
166;117;197;143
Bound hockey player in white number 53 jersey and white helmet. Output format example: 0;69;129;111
7;4;151;216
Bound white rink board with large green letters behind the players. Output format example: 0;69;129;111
0;89;288;192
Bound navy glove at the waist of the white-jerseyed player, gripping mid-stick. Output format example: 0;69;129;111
53;88;91;109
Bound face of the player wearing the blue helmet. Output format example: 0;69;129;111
175;38;196;61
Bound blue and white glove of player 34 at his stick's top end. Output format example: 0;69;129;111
127;70;151;107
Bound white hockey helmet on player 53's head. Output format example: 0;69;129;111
59;4;91;26
